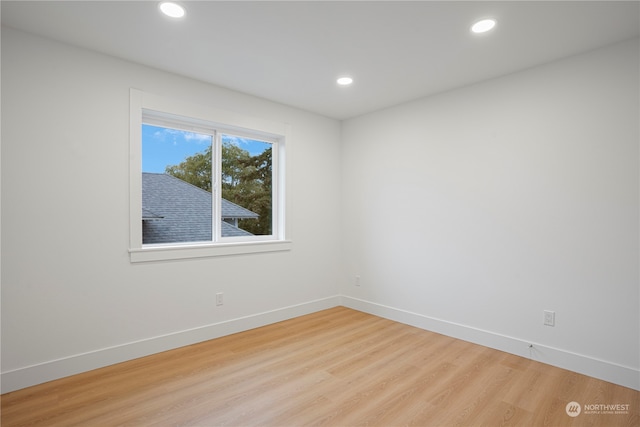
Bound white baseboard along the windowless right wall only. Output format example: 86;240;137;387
341;296;640;390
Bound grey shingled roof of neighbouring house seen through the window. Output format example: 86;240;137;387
142;172;258;243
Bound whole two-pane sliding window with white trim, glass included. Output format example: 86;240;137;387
130;89;290;262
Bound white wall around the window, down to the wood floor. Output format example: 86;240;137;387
2;28;340;391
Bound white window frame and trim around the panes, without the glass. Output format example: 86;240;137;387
129;89;292;262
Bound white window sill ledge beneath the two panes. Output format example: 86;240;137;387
129;240;292;263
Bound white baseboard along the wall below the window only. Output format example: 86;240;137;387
0;296;340;393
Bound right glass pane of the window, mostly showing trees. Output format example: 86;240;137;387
221;134;273;237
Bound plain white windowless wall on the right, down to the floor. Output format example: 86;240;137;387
342;40;640;388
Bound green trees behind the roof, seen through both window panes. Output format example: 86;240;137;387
165;143;273;235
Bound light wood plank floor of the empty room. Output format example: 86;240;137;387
2;307;640;427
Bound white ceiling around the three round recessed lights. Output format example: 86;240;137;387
1;0;640;119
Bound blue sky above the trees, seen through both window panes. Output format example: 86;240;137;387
142;125;270;173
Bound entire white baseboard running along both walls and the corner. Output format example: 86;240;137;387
0;296;640;393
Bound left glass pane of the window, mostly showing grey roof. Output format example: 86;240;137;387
142;124;213;244
